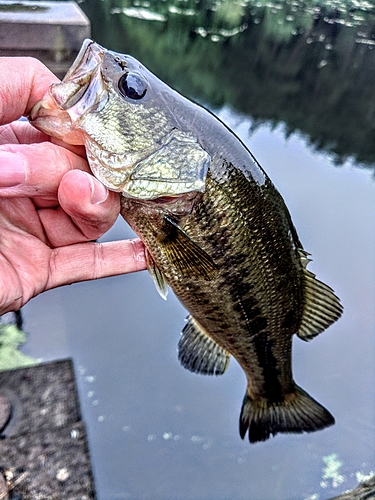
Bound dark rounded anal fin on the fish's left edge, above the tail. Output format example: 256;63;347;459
178;316;230;375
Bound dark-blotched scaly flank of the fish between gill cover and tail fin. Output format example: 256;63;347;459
122;165;302;400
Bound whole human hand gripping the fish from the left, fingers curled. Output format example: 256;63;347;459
0;58;146;314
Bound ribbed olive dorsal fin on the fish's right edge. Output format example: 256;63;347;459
297;250;343;341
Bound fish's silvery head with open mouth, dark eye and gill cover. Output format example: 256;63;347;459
29;40;211;200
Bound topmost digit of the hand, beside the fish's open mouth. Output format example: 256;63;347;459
0;57;59;125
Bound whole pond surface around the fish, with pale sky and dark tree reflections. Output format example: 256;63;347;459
21;0;375;500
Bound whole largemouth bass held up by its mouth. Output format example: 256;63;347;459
30;40;342;442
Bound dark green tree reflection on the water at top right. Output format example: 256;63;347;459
81;0;375;166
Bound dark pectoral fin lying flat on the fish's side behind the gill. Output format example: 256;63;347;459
157;215;218;281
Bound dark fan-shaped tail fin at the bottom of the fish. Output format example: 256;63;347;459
240;386;335;443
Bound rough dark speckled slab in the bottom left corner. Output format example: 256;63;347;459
0;360;96;500
